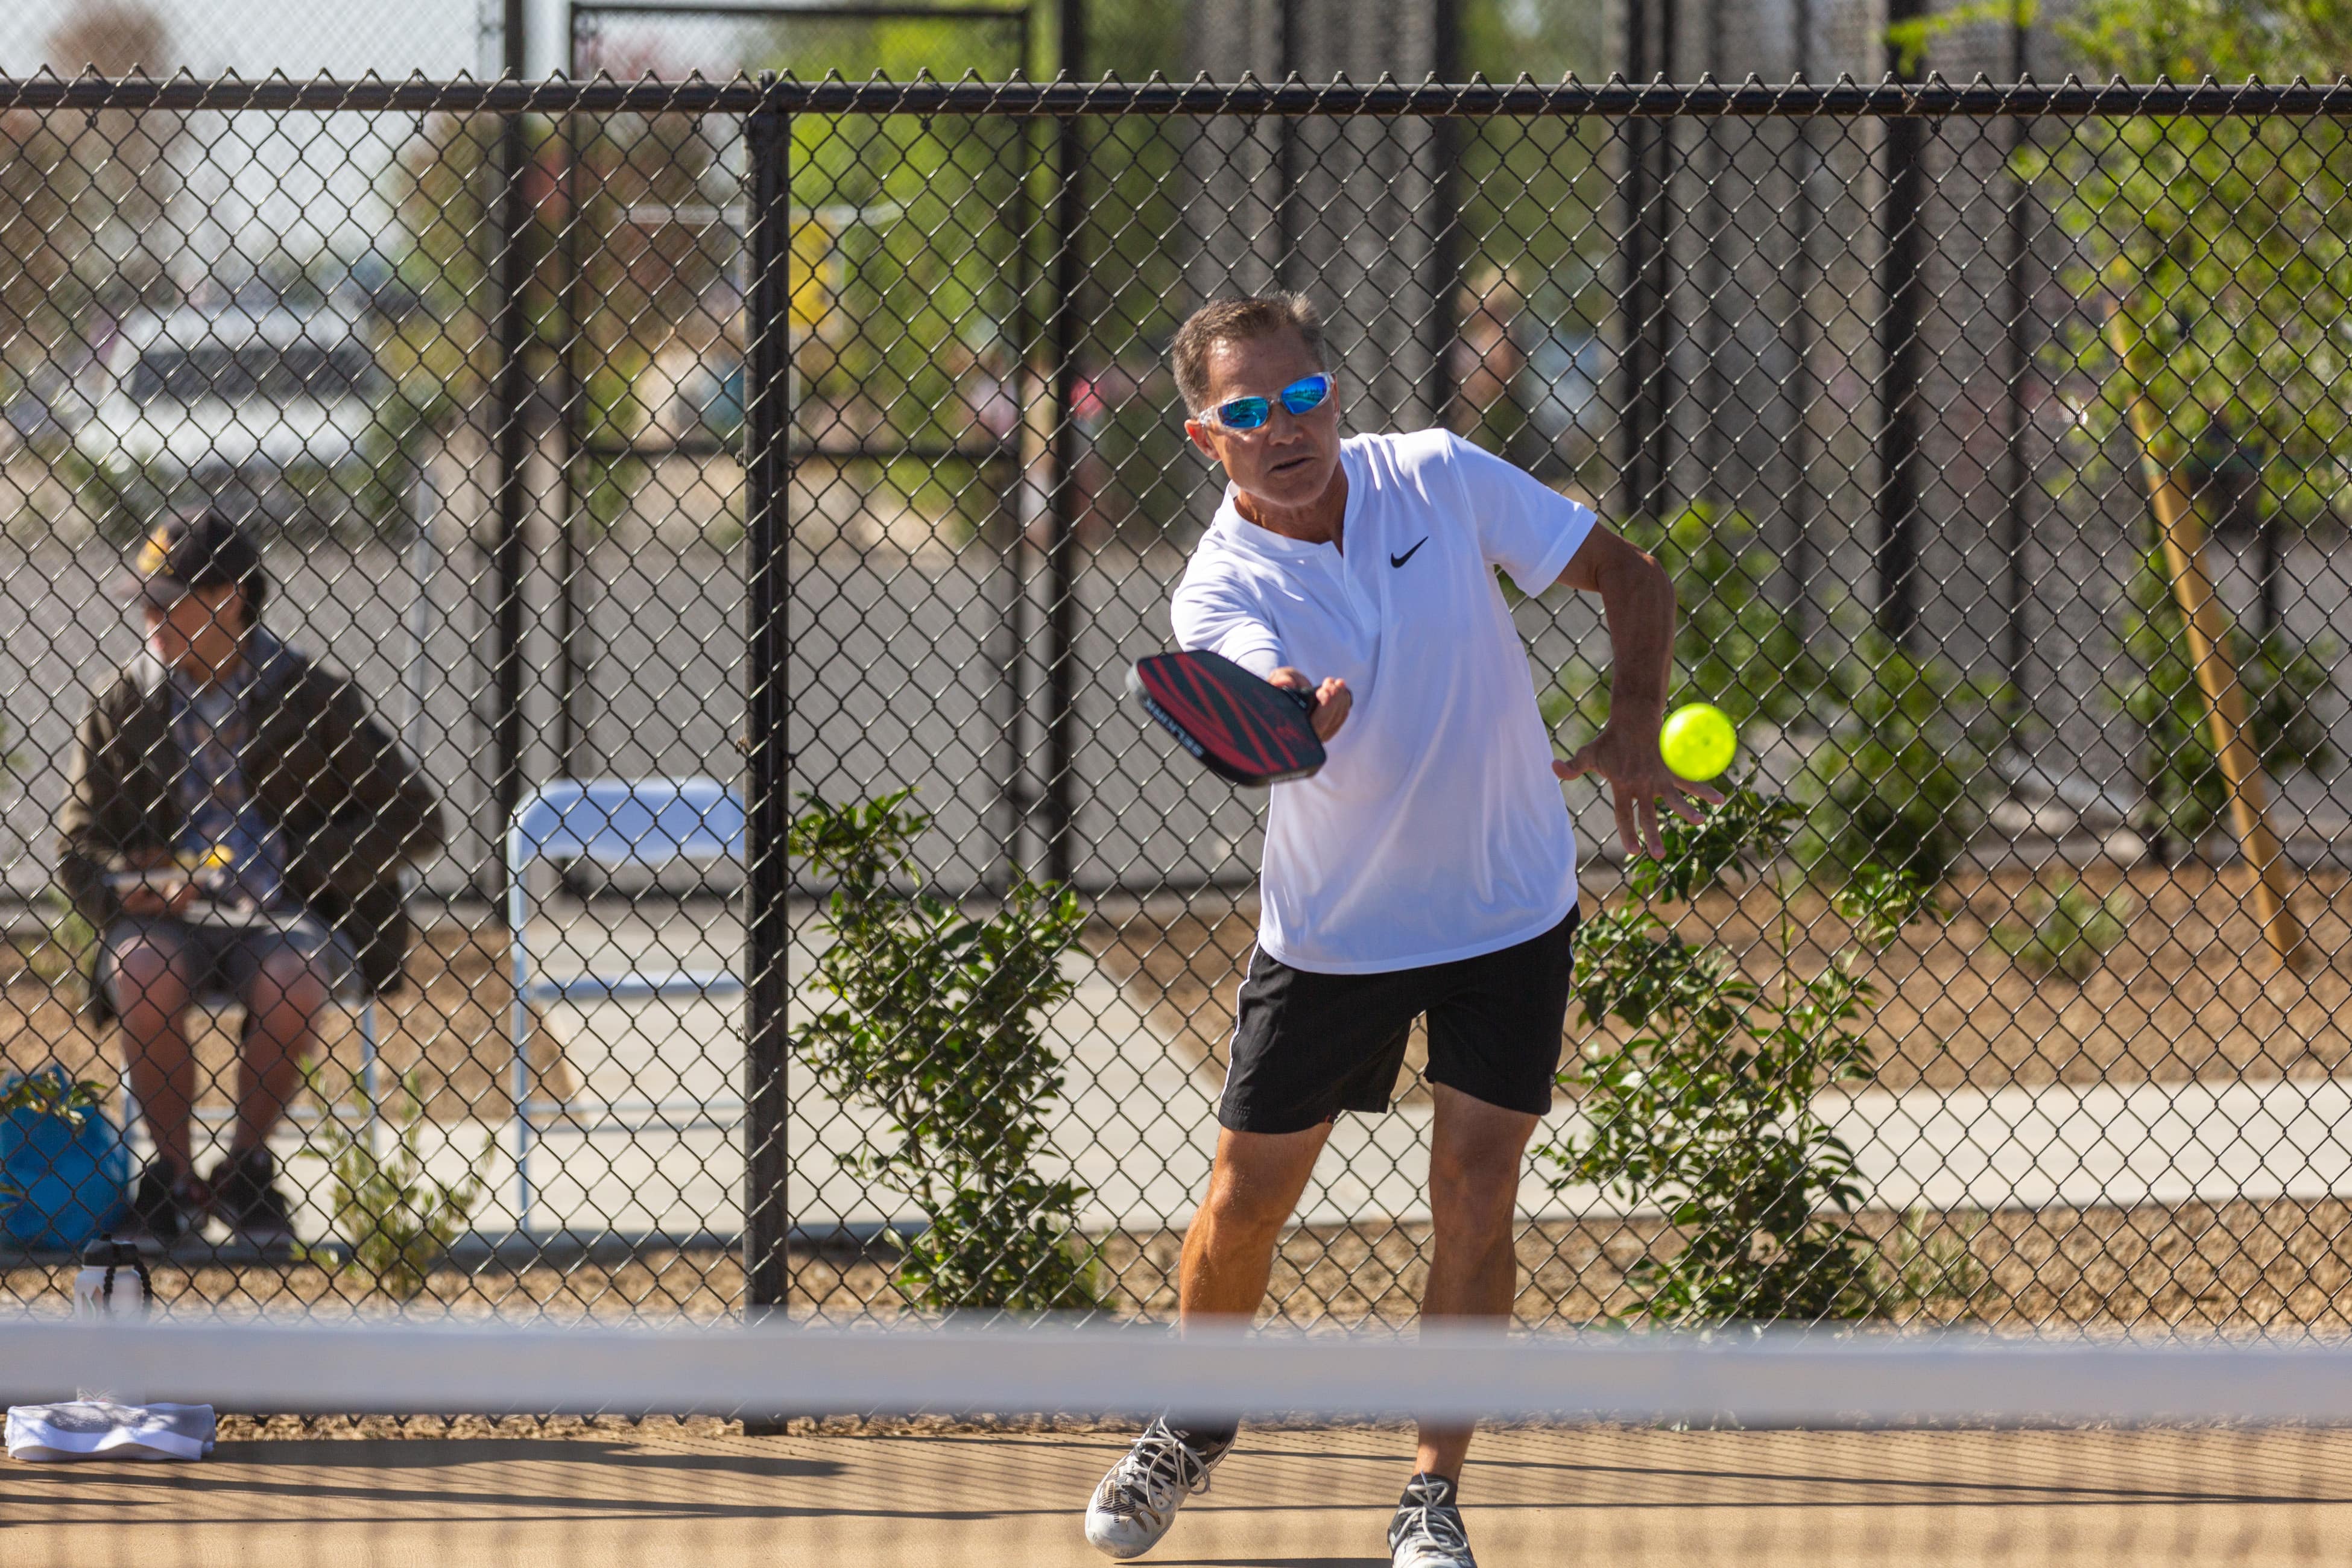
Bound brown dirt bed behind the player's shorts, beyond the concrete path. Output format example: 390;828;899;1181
1087;865;2352;1098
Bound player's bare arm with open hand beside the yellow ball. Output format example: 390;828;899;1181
1552;529;1722;856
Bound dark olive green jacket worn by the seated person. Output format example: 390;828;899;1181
57;642;442;994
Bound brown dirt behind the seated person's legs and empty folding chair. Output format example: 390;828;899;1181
0;924;574;1121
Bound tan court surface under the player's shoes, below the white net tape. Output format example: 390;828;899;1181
0;1422;2352;1568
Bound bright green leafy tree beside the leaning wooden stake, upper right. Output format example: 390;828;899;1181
2018;0;2352;860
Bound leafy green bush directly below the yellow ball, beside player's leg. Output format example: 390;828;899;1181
1541;780;1931;1324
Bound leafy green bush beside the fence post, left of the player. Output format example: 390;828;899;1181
790;790;1101;1312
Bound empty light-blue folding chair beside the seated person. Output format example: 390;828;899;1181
506;778;745;1230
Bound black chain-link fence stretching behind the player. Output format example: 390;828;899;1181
0;80;2352;1326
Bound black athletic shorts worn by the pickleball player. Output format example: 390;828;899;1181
1216;910;1576;1133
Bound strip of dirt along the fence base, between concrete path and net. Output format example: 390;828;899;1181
0;1199;2352;1333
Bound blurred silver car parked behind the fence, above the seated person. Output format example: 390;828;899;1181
73;308;419;539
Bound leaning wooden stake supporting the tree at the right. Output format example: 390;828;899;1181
2107;311;2303;966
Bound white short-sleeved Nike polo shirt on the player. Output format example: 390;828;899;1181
1171;430;1595;976
